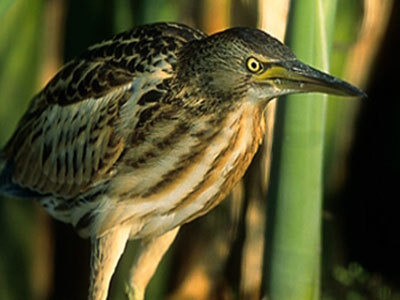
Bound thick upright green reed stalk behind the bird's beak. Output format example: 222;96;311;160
264;0;336;300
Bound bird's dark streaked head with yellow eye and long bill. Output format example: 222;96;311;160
179;28;365;106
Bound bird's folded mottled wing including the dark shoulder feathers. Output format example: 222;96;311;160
0;24;202;198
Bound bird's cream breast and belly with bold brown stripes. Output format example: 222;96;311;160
101;102;265;237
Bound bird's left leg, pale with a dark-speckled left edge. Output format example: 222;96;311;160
89;228;129;300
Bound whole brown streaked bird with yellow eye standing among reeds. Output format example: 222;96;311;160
0;22;365;300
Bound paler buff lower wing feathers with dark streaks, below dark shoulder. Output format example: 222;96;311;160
4;87;130;198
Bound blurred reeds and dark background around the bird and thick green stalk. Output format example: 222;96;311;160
0;0;400;300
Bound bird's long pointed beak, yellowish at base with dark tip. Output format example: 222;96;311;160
258;60;367;97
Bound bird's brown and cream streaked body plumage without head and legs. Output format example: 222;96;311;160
3;24;265;238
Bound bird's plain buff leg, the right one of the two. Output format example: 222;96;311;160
128;227;179;300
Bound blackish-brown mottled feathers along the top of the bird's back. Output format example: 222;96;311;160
44;23;205;105
